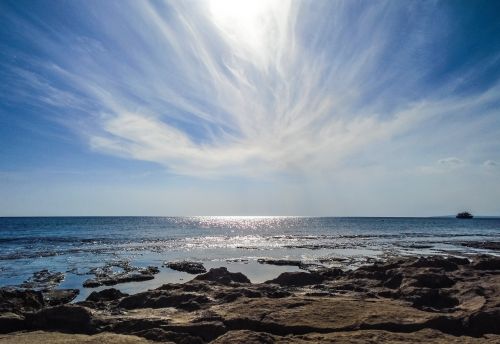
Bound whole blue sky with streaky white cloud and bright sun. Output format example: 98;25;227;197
0;0;500;216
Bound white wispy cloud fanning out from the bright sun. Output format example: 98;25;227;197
2;0;500;177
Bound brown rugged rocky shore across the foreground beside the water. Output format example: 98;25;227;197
0;256;500;344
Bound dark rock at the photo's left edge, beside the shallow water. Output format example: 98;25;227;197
0;288;45;313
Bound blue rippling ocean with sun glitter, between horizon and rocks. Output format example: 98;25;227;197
0;216;500;300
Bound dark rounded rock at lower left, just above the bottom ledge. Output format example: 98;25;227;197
26;305;96;333
